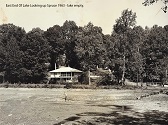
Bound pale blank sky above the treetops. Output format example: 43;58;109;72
0;0;168;34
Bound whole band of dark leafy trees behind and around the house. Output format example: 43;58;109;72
0;9;168;83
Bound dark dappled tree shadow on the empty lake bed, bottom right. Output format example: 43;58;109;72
54;105;168;125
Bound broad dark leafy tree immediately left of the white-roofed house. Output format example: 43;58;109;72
20;28;50;83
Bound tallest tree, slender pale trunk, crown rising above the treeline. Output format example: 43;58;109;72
113;9;136;85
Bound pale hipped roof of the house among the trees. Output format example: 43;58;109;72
50;67;82;73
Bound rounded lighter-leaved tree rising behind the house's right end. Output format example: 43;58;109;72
75;23;106;71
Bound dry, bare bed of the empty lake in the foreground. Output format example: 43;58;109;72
0;88;168;125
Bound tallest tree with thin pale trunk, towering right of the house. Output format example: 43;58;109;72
113;9;136;84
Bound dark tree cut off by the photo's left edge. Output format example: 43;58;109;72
0;24;25;82
